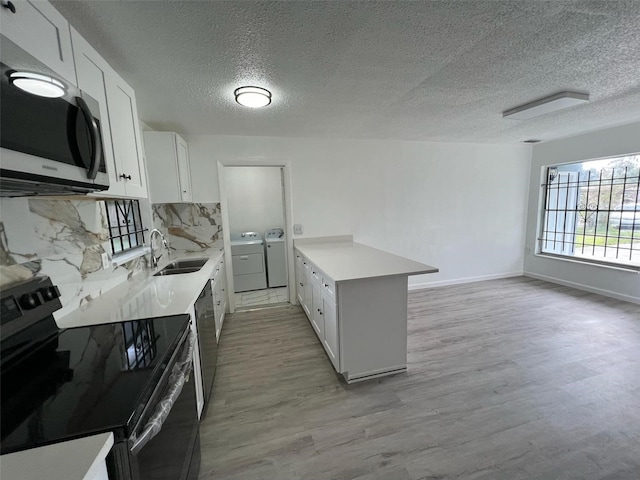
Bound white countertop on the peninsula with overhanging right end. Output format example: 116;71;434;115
294;238;438;282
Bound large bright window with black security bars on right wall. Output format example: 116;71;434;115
538;155;640;270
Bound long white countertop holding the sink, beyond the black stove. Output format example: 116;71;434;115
54;249;223;328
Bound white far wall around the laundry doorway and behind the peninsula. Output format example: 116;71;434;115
188;136;531;286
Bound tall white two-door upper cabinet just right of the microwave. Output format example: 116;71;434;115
71;28;148;198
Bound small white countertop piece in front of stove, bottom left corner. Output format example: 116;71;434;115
0;432;113;480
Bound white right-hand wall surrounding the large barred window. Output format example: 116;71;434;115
524;123;640;303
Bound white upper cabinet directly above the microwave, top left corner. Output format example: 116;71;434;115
0;0;76;85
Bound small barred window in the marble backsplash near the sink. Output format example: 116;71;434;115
104;200;147;255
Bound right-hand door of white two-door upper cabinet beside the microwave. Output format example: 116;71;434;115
107;71;148;198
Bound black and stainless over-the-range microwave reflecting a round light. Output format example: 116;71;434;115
0;36;109;197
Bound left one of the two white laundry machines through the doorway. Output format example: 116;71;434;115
231;232;267;293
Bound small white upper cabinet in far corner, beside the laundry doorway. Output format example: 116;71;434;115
144;132;192;203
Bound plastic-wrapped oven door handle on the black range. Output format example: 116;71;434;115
129;332;196;455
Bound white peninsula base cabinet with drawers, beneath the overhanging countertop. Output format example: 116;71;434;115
296;248;407;383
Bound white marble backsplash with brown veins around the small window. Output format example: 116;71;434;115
0;198;223;318
